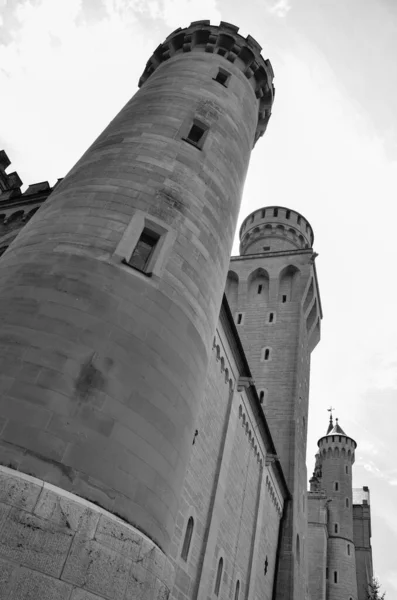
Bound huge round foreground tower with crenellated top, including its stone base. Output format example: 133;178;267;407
0;21;272;600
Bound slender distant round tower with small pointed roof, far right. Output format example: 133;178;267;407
318;417;357;600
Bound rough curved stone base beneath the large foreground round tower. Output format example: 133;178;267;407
0;466;174;600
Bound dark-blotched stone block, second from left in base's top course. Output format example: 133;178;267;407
34;484;100;539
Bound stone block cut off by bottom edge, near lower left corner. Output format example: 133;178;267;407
7;568;72;600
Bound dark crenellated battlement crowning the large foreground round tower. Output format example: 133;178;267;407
138;20;275;142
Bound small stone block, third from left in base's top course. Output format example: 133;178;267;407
95;515;142;560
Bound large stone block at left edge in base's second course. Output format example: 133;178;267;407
0;508;73;577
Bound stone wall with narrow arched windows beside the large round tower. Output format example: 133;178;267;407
166;316;283;600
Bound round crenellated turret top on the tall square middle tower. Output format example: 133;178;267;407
240;206;314;256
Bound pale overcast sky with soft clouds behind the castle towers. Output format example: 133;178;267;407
0;0;397;600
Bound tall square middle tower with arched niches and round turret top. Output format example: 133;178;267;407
226;206;321;600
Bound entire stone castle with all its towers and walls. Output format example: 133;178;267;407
0;21;372;600
